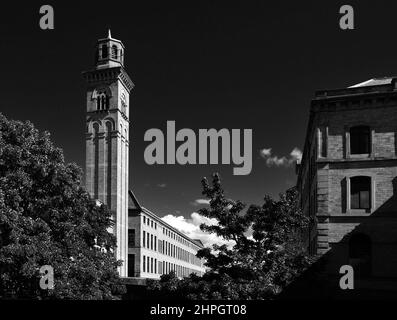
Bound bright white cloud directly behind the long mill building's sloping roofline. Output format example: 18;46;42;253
162;212;234;247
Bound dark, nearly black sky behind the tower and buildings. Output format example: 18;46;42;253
0;0;397;216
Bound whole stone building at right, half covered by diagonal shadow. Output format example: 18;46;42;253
297;78;397;292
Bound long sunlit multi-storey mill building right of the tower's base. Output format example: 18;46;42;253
128;191;205;279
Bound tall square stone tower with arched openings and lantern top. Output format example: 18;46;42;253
83;31;134;277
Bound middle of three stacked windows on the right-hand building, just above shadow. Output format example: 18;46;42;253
350;176;371;209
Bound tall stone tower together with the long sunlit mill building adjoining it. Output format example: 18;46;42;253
83;31;204;278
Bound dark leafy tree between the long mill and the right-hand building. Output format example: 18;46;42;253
149;174;312;299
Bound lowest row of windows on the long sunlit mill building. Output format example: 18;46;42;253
142;255;202;277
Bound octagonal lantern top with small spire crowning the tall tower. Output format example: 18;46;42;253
95;29;124;69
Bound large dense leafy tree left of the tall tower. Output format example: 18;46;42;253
0;114;123;299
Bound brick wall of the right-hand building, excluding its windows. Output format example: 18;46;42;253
298;87;397;277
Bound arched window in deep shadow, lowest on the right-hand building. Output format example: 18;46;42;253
349;233;372;277
